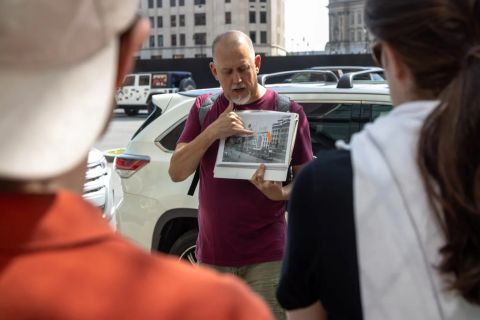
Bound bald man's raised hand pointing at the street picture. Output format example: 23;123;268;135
206;101;253;139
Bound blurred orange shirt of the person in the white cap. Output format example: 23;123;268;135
0;192;272;319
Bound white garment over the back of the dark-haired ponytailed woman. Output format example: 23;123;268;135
351;101;480;320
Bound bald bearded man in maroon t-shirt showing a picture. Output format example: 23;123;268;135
169;31;313;318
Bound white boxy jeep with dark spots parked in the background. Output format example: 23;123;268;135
115;71;196;116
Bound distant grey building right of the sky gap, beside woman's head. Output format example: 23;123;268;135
325;0;373;54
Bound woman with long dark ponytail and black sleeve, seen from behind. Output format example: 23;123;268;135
277;0;480;320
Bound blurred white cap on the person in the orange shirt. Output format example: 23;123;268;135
0;0;138;180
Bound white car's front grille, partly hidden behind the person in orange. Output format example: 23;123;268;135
83;148;116;228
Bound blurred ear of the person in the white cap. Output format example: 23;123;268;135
115;18;150;88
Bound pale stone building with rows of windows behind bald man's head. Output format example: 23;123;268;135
139;0;286;59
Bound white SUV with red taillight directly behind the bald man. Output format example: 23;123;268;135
115;68;392;262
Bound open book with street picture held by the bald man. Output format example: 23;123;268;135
214;110;298;181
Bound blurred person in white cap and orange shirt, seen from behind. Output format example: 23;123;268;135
0;0;271;319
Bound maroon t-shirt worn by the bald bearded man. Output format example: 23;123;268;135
178;90;313;267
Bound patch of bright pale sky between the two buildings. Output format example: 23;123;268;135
285;0;328;51
